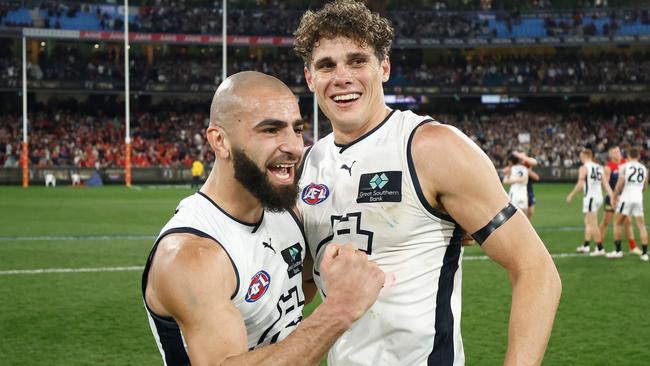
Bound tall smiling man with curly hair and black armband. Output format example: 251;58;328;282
294;0;561;366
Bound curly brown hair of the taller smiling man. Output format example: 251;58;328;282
293;0;394;65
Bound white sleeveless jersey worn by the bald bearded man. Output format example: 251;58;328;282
142;192;305;365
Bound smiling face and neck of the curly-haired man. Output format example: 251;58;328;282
305;36;390;143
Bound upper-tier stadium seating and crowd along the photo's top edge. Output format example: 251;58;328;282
0;0;650;38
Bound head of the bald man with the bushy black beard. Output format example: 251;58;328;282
208;72;304;210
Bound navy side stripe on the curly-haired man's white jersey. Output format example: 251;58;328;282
427;225;464;365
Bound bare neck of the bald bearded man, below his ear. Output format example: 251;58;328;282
201;163;264;224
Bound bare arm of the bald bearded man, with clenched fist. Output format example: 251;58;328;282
146;234;383;365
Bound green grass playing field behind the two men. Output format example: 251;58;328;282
0;184;650;365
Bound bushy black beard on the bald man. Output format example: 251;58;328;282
232;148;298;212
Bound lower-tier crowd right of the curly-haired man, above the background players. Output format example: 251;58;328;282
436;111;650;168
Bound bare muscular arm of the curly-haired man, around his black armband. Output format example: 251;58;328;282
413;125;561;365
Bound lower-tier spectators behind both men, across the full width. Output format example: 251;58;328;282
0;103;650;167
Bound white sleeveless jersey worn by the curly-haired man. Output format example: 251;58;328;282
299;111;464;366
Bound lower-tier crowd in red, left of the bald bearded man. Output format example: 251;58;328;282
0;111;214;168
